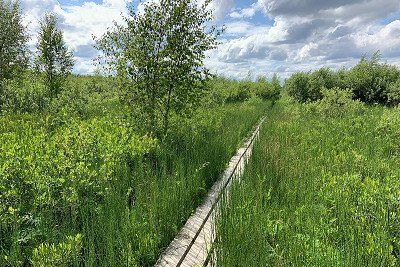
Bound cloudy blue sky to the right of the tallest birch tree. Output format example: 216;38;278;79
208;0;400;77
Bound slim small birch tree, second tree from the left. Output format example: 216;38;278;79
35;13;74;98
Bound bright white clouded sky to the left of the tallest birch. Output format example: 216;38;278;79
21;0;128;73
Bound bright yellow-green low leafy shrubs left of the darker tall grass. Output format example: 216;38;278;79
0;114;155;266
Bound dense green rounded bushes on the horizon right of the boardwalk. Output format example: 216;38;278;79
285;52;400;105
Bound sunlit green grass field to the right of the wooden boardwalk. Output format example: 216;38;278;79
214;102;400;266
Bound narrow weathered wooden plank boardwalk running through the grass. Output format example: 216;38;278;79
155;118;265;267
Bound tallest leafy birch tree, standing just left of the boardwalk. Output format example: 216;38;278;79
97;0;218;138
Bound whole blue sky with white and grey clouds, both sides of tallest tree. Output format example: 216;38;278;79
22;0;400;78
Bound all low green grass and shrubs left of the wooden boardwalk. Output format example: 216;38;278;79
0;97;270;266
